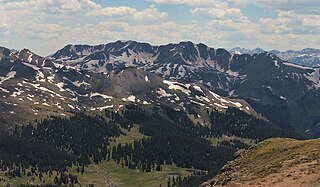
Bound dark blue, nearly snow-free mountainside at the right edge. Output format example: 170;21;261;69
233;53;320;133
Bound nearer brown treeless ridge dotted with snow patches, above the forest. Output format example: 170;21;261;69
0;44;256;131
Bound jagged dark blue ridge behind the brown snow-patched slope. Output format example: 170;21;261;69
50;41;320;137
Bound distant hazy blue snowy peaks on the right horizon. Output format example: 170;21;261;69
229;47;320;67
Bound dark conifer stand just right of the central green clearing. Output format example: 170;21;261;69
106;105;237;172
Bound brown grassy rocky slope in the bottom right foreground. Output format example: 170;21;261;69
201;138;320;187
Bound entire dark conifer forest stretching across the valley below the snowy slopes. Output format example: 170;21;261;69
0;105;295;186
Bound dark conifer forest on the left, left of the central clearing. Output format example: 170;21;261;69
0;114;121;185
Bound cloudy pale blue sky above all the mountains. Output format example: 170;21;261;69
0;0;320;55
